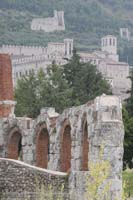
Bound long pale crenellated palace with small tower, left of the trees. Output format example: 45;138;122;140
0;39;73;86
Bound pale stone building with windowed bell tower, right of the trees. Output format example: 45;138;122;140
79;35;131;100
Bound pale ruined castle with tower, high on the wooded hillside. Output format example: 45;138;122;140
31;10;65;32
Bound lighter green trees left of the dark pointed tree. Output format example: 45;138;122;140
15;63;72;118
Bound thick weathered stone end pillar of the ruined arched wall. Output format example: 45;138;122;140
89;94;124;200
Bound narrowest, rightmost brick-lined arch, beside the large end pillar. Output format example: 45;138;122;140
82;122;89;171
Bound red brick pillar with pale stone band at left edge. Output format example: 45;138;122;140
0;54;16;117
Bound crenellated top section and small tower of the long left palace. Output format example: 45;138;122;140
0;39;73;58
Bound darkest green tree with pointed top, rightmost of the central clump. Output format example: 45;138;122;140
64;50;111;105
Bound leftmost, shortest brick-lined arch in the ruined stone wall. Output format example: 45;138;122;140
8;128;22;160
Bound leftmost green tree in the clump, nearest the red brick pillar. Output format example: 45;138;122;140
15;73;39;118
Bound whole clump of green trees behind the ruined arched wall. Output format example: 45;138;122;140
15;53;110;117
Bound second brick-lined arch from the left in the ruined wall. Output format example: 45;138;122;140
36;123;49;168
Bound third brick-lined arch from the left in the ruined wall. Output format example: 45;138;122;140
61;120;71;172
